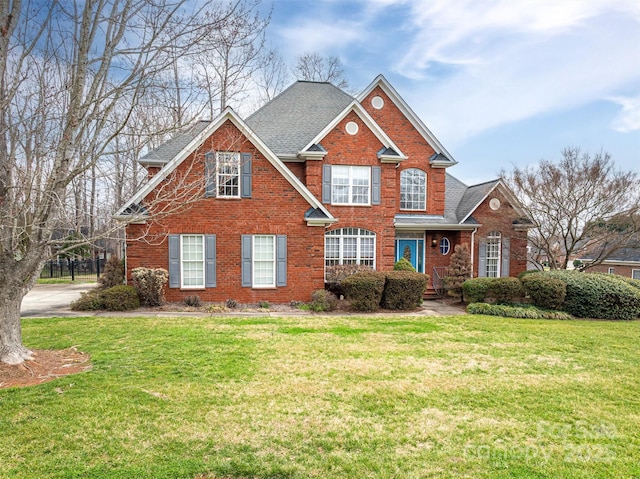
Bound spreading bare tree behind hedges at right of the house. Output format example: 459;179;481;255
502;148;640;269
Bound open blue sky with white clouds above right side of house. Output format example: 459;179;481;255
263;0;640;183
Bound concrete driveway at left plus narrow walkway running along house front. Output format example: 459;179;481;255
20;283;466;318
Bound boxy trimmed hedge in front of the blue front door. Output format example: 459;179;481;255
381;270;429;310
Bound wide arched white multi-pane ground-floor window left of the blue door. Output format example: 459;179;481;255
324;228;376;268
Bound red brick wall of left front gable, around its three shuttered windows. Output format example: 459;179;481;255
127;123;324;303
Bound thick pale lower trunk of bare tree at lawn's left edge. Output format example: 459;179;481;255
0;285;33;364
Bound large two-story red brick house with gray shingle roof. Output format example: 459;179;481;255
116;76;530;303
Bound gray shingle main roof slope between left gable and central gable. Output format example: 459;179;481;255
246;81;354;156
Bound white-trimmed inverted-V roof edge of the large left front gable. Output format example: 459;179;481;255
114;108;336;224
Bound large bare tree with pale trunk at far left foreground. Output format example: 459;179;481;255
0;0;228;364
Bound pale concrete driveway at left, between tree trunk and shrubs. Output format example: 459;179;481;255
20;283;96;318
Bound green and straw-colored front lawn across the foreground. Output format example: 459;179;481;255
0;316;640;478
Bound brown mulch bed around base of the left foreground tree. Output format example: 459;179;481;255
0;347;91;389
